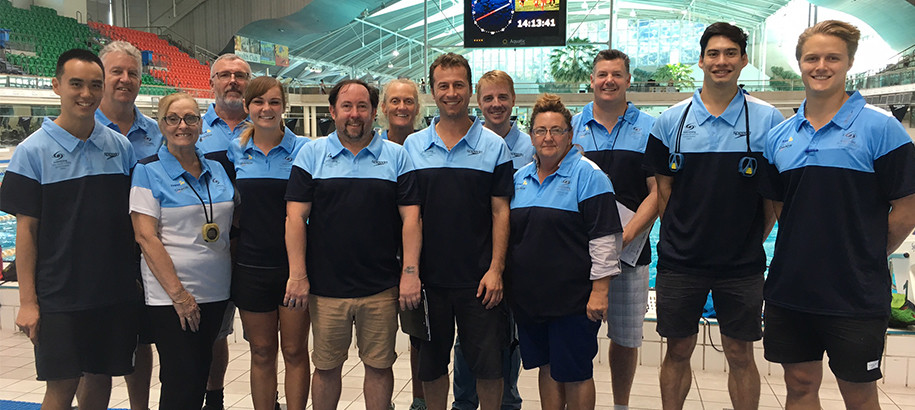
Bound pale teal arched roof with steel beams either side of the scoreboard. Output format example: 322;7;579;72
238;0;796;83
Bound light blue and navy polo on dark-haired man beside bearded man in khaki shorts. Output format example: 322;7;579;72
404;117;513;288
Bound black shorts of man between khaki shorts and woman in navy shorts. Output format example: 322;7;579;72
419;288;510;382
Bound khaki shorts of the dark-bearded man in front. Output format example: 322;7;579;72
308;287;399;370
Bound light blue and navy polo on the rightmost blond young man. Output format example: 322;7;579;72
761;92;915;317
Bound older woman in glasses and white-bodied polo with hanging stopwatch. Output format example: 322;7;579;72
130;93;235;410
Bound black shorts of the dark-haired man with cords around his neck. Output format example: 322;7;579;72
655;268;765;342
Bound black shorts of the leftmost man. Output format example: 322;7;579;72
35;302;138;381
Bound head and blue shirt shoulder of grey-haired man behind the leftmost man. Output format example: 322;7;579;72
95;41;162;160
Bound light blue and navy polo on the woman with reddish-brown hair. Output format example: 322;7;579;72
505;147;623;322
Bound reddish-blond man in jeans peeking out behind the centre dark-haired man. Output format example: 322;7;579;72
451;70;534;410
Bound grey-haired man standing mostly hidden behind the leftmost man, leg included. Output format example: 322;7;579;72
95;41;162;409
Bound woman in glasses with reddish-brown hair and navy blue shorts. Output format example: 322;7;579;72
506;94;623;409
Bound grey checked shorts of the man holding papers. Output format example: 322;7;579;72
607;263;648;348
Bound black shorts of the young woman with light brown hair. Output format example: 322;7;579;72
232;264;289;313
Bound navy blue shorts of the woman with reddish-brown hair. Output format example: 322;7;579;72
518;314;600;383
